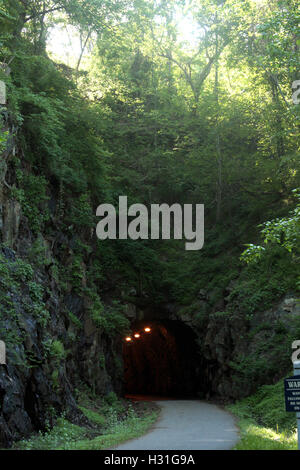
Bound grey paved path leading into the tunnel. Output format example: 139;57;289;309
110;400;239;450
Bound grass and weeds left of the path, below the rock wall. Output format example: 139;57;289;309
14;397;159;450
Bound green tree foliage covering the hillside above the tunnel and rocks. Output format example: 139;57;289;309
1;1;299;330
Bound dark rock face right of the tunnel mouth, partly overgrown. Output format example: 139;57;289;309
203;294;300;399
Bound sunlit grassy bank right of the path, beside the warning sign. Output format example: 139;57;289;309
227;380;297;450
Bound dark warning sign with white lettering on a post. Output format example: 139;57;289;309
284;361;300;450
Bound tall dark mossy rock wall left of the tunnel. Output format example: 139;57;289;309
0;114;127;447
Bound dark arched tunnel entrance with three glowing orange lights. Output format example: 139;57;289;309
123;320;203;398
